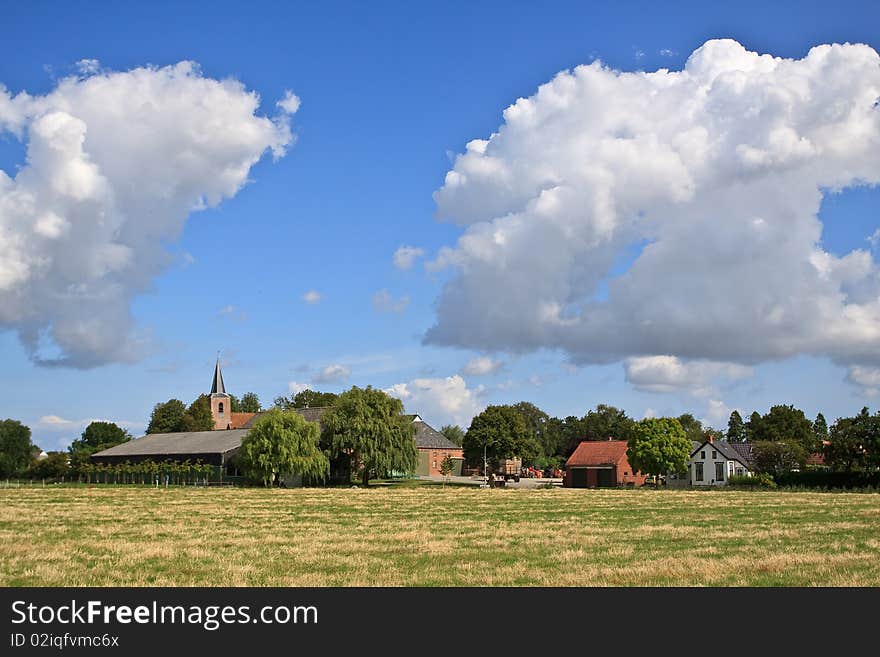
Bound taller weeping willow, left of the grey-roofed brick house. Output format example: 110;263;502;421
321;386;418;486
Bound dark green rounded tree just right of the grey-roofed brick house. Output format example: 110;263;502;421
462;406;540;468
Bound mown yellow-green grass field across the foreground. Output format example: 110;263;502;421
0;486;880;586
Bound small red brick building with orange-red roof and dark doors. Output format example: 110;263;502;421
562;440;645;488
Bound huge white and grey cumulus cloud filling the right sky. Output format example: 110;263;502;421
426;40;880;387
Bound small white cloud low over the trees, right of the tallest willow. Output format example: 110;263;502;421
385;374;486;429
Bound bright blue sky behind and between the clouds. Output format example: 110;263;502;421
0;2;880;449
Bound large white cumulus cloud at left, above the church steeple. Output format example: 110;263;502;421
0;62;299;367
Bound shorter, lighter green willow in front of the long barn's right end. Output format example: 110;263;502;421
238;408;330;486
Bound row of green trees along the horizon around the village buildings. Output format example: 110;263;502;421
0;386;880;484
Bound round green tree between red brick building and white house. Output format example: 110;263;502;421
626;417;691;482
